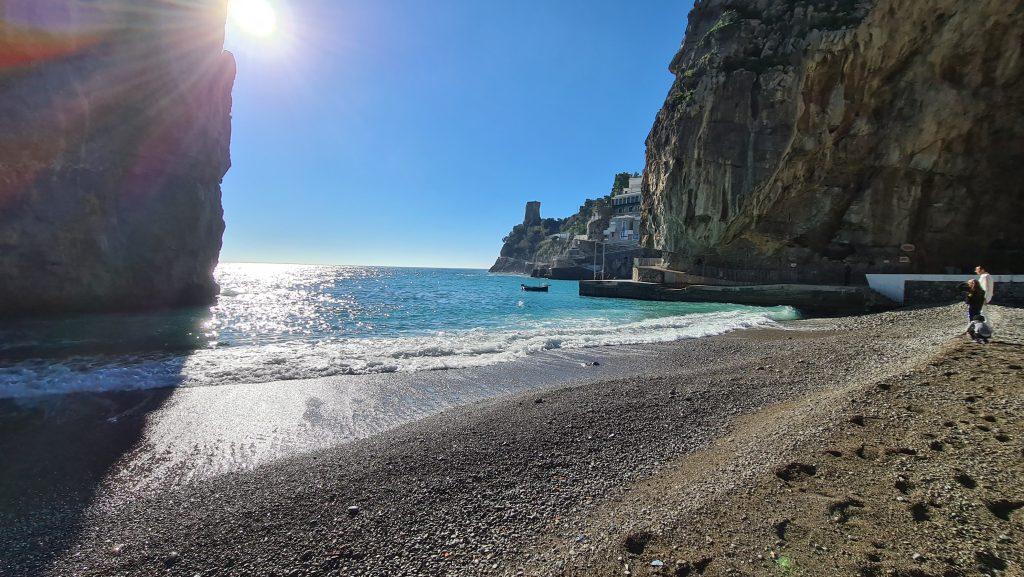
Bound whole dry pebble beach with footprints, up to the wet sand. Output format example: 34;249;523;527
0;306;1024;576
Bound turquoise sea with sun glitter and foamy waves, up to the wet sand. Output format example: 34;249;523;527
0;263;798;399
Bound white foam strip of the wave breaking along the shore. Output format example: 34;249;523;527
0;308;796;398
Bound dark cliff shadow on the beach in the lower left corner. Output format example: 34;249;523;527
0;388;173;575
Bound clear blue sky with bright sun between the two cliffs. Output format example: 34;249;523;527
221;0;692;267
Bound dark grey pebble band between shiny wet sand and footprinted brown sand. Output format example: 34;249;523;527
7;307;1015;575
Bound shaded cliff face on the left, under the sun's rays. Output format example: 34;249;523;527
0;0;234;315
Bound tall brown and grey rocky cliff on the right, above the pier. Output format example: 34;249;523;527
643;0;1024;281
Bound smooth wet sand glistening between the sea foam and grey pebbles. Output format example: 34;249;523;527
0;320;813;492
